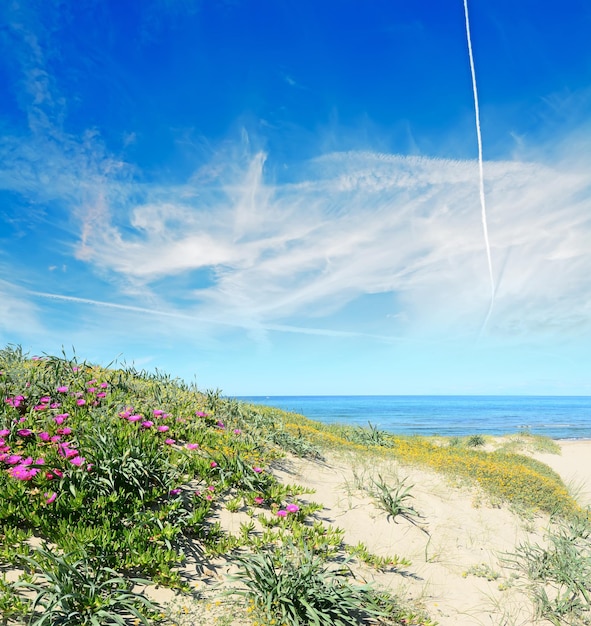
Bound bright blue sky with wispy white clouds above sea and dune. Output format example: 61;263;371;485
0;0;591;395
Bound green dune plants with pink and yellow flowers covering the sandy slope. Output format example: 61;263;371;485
0;347;587;626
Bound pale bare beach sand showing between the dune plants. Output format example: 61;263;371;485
151;441;591;626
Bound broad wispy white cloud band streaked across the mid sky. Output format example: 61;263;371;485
53;138;591;333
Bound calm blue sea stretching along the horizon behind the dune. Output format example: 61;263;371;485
238;396;591;439
